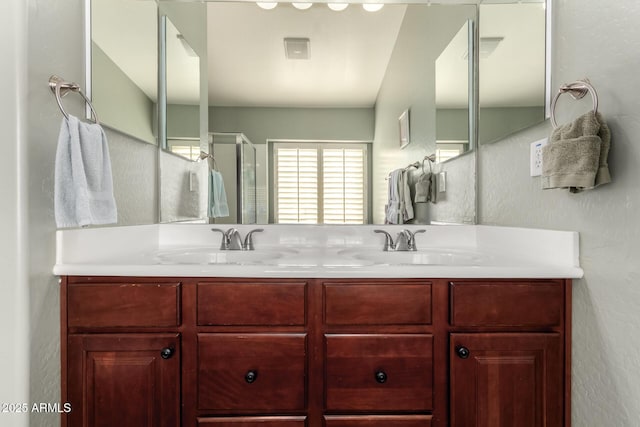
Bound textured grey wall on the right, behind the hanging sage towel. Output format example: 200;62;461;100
479;0;640;426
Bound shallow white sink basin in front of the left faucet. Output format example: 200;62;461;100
154;248;286;264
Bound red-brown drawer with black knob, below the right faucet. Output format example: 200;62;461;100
325;334;433;411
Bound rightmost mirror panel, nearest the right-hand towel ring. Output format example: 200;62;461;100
479;0;547;144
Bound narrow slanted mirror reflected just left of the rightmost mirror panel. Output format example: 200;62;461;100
435;22;471;163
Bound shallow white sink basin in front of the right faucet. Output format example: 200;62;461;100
340;249;485;266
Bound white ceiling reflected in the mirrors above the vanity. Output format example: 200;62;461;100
92;0;545;107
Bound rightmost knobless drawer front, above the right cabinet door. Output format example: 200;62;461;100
450;281;564;327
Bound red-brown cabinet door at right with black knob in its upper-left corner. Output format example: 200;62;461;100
450;333;564;427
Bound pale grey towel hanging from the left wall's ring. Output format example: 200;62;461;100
54;115;118;228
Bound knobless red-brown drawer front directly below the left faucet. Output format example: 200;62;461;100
198;282;307;326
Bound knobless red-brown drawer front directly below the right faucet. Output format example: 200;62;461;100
324;283;431;325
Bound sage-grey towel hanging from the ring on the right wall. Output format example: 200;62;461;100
542;111;611;193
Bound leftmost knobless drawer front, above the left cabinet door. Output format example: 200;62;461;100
67;283;181;328
